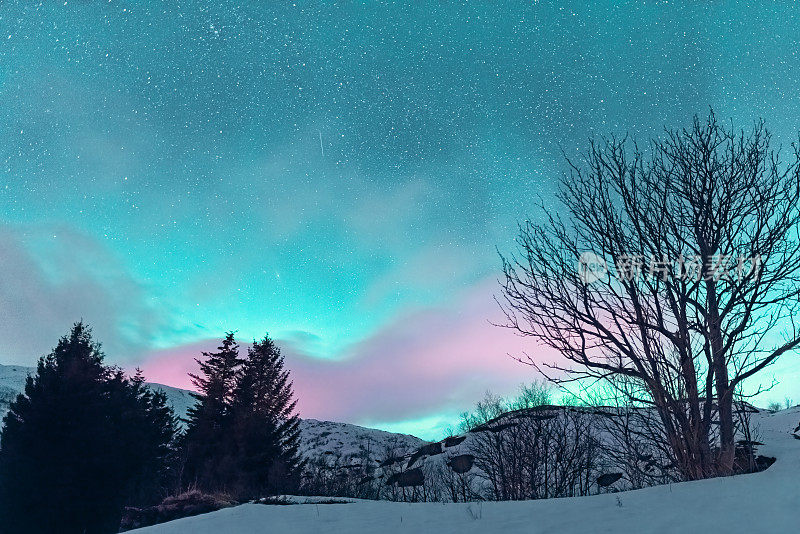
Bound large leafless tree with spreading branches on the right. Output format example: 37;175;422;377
500;112;800;479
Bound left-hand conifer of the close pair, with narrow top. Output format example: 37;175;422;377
183;332;242;491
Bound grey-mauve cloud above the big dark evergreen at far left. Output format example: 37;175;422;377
0;225;166;365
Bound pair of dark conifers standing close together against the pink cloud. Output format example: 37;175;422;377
183;332;303;499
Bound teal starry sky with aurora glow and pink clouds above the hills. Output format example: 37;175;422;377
0;0;800;437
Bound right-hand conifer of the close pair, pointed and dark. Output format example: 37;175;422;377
232;336;303;498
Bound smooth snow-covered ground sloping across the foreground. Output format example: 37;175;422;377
134;407;800;534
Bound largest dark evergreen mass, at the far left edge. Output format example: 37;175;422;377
0;323;174;534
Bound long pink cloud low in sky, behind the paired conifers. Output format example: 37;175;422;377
138;279;556;436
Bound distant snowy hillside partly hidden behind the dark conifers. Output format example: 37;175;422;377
0;365;427;463
